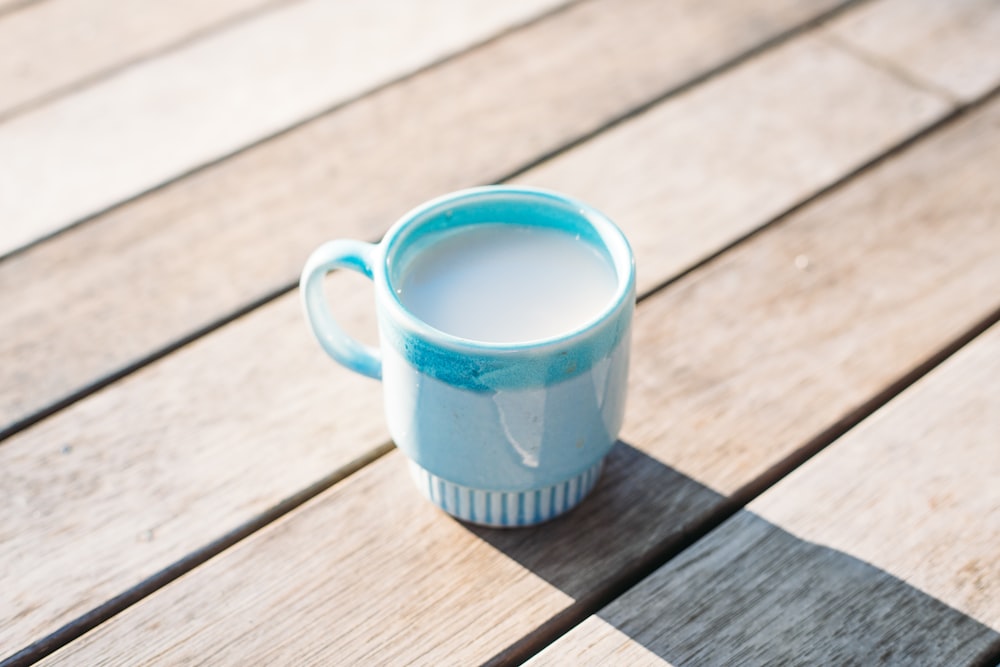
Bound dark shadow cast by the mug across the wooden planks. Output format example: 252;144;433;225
469;443;1000;667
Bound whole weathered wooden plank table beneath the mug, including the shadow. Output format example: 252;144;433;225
0;0;1000;665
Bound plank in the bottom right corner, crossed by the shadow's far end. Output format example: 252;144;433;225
531;324;1000;665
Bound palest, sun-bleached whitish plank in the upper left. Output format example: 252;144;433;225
0;0;565;254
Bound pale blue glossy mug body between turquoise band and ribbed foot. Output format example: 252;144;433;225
383;333;629;492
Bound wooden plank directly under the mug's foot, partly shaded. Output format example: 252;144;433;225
31;40;1000;664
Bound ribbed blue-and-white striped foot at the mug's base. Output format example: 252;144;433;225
409;460;604;528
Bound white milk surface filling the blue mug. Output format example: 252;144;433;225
397;223;617;343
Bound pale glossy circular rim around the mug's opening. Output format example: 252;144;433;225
373;185;635;354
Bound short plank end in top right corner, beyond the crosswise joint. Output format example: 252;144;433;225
831;0;1000;100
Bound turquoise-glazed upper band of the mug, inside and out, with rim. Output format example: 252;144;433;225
375;187;635;392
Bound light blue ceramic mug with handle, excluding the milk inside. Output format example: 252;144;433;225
300;186;635;526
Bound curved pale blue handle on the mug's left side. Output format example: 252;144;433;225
299;239;382;380
